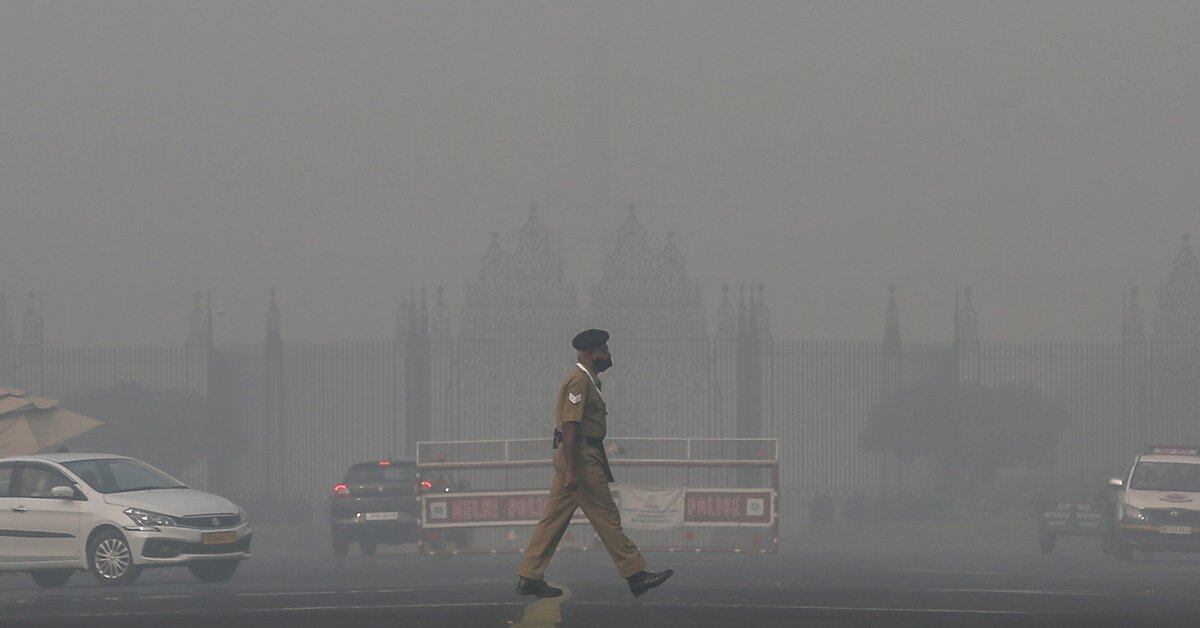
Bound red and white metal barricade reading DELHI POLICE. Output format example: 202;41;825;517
416;437;779;555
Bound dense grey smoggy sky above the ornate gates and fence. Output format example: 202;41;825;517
0;0;1200;345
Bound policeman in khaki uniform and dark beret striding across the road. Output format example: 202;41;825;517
517;329;673;598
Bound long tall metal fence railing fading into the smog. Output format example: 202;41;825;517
9;339;1200;509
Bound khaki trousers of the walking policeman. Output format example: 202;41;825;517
517;441;646;580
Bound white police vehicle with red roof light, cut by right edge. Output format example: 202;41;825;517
1109;445;1200;561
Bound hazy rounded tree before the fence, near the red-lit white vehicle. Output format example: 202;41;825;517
859;383;1070;489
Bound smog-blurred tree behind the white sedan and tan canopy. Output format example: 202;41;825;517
65;382;241;482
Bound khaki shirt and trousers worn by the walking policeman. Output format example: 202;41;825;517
517;365;646;580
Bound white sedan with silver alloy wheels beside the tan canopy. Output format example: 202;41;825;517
0;454;252;587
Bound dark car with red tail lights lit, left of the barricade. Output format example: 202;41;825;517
330;460;421;556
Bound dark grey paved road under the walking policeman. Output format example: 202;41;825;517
7;542;1200;628
